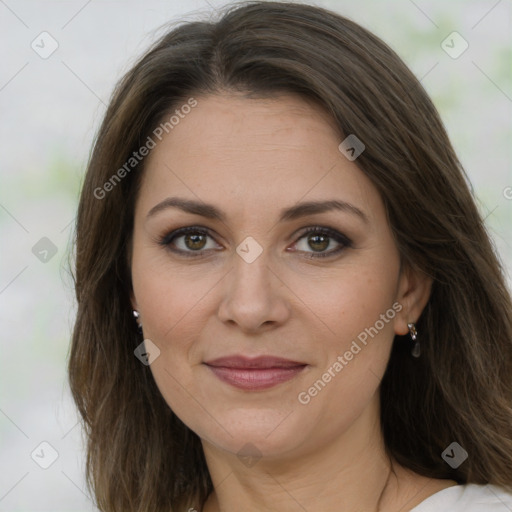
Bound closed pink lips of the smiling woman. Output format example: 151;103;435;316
205;356;307;391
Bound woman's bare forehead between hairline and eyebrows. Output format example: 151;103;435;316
139;94;382;224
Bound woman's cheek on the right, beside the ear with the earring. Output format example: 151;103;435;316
295;254;401;412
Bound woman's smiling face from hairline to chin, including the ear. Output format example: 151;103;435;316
132;94;429;458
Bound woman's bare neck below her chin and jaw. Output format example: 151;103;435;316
203;400;412;512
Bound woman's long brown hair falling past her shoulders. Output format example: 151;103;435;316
68;2;512;512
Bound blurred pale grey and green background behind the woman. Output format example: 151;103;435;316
0;0;512;512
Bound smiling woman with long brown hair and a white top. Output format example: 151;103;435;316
69;2;512;512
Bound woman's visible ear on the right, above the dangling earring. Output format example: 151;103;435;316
395;265;432;335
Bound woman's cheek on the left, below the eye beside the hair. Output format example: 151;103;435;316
132;249;218;408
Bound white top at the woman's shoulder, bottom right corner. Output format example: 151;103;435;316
411;484;512;512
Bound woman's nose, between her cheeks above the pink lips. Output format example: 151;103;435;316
218;250;290;333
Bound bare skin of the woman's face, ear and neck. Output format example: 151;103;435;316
132;92;455;512
